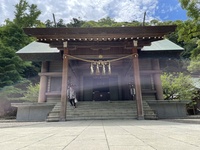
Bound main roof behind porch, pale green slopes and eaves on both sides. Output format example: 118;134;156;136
16;39;184;61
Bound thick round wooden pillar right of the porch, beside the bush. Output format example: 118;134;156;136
152;59;164;100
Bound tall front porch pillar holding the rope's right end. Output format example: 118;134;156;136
132;41;144;120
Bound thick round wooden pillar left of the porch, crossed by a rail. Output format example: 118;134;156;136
38;61;49;103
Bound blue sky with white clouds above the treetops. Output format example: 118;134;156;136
0;0;187;24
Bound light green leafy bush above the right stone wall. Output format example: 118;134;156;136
161;73;196;100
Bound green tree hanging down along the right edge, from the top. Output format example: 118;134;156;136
178;0;200;72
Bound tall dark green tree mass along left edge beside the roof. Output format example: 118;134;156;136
0;0;41;88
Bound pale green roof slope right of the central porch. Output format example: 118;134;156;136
142;39;184;51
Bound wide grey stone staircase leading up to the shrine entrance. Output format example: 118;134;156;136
47;101;157;122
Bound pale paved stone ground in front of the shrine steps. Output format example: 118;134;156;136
0;119;200;150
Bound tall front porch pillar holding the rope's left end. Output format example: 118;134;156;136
60;42;69;121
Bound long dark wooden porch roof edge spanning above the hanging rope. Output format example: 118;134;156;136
24;25;176;40
